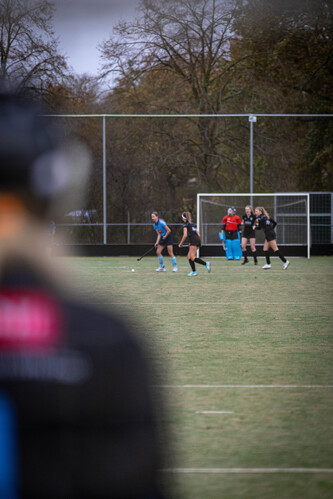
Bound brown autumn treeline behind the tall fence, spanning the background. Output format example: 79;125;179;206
0;0;333;227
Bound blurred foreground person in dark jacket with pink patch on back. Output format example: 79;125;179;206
0;93;166;499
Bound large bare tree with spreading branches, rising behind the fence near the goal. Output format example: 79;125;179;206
100;0;246;189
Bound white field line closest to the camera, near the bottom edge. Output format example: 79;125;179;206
161;468;333;473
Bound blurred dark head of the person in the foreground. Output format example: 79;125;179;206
0;90;89;221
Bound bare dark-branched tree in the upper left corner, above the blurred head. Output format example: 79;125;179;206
0;0;66;92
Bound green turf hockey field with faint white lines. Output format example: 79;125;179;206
63;257;333;499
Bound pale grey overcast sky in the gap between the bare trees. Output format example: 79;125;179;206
54;0;139;75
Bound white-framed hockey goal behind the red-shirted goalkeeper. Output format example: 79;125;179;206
197;192;311;258
